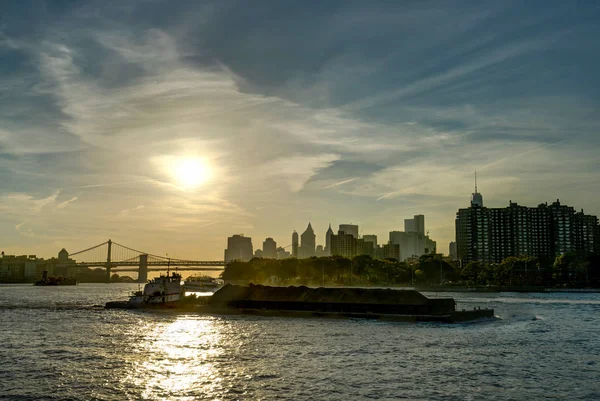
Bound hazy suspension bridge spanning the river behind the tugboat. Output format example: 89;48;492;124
65;240;225;282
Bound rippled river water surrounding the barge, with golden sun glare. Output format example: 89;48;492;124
0;284;600;400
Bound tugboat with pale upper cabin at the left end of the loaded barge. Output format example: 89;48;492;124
105;272;183;309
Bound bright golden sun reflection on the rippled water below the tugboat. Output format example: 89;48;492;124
125;316;222;400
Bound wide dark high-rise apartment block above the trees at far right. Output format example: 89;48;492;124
455;190;600;264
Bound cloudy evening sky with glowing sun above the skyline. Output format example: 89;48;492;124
0;0;600;260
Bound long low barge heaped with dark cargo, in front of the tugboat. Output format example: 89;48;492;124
199;284;494;322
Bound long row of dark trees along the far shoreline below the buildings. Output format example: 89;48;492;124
221;254;600;288
